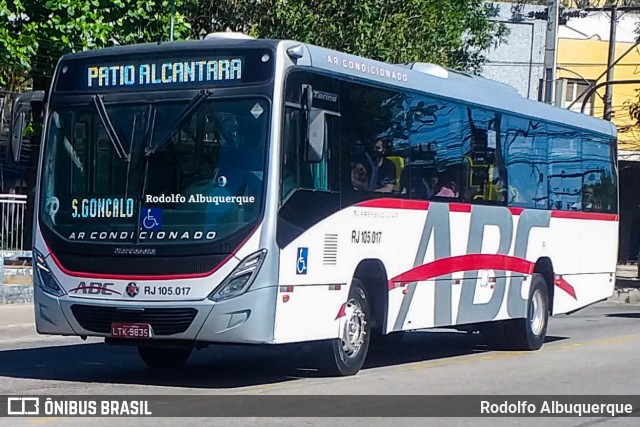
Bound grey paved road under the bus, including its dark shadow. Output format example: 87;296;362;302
0;303;640;426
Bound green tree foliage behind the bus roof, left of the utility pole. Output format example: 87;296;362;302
185;0;507;72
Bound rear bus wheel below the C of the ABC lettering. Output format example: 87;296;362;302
505;273;549;351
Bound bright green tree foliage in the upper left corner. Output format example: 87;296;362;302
0;0;189;89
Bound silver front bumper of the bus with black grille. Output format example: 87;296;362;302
34;286;277;344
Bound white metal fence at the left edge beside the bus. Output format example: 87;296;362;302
0;194;30;251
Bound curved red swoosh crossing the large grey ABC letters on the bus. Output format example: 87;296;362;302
389;254;577;299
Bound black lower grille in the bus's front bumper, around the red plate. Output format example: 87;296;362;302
71;304;198;335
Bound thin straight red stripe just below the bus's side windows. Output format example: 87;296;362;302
356;198;619;221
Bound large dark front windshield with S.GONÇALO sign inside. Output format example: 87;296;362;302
41;97;269;244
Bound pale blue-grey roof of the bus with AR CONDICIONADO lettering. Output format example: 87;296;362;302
55;38;617;136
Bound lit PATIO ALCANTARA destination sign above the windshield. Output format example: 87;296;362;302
86;58;243;88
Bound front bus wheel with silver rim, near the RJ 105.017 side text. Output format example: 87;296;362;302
320;279;371;376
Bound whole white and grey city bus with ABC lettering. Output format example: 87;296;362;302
27;36;618;375
